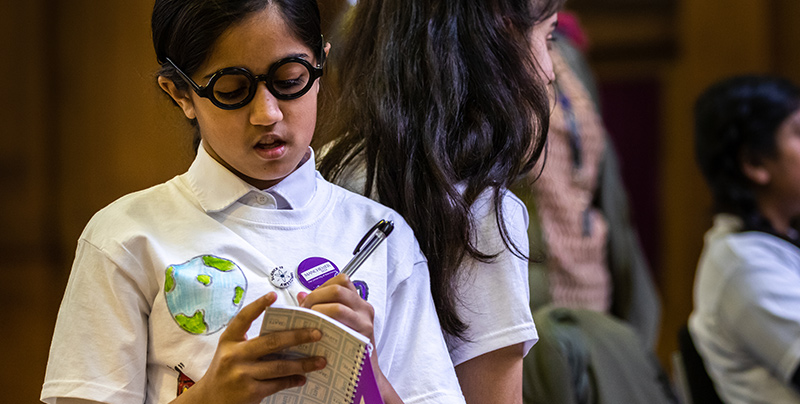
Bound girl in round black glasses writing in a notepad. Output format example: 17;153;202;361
41;0;464;404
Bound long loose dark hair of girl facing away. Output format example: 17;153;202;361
318;0;564;336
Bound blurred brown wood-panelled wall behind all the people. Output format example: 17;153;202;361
6;0;800;403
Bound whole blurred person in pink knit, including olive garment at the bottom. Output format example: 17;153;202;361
514;19;676;404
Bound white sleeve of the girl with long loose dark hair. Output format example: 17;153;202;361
446;190;539;365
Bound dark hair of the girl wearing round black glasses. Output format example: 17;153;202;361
151;0;324;146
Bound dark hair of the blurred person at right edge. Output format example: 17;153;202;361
694;75;800;234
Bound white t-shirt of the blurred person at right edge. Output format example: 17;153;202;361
689;215;800;404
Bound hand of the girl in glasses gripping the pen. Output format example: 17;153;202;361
297;274;375;345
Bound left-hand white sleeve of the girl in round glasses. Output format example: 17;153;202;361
41;240;150;403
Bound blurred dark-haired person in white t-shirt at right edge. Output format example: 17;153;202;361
689;76;800;404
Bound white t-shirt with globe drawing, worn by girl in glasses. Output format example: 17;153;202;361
41;147;464;403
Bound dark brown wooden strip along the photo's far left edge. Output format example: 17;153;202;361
0;0;64;403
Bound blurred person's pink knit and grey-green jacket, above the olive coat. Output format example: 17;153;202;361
514;18;661;348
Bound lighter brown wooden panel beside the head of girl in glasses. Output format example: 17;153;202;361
56;0;192;251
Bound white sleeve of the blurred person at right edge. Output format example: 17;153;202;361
719;254;800;383
